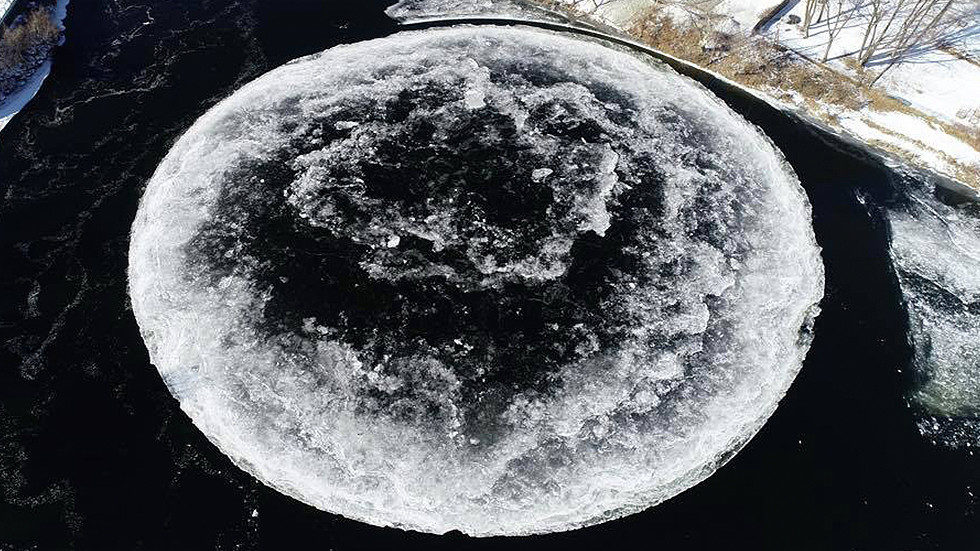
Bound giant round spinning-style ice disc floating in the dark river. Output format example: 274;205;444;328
130;26;823;535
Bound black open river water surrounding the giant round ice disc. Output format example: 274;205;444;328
0;0;980;550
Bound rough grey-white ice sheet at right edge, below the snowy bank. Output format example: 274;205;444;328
889;185;980;446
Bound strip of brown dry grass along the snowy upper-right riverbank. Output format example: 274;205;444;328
535;0;980;190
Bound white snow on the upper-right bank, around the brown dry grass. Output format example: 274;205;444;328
566;0;980;188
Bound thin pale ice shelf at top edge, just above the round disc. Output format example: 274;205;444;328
385;0;565;23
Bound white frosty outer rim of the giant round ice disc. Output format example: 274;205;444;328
130;27;823;536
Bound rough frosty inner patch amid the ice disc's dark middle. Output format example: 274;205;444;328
287;74;620;286
